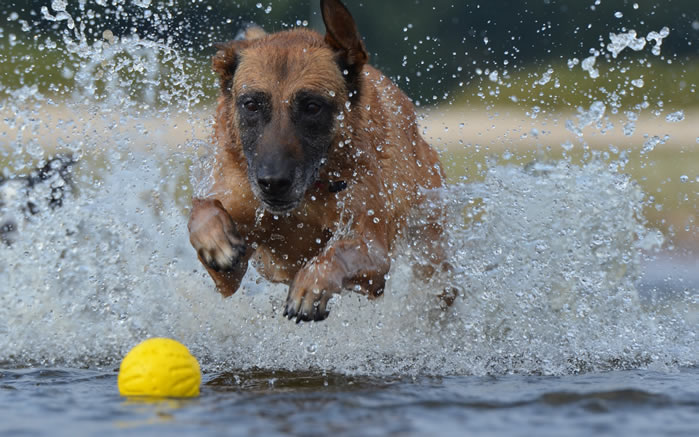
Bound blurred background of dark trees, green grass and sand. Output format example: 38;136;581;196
0;0;699;257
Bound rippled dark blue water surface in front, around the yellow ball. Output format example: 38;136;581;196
0;368;699;436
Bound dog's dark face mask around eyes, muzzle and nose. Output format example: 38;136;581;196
235;85;339;213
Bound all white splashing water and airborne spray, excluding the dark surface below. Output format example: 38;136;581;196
0;0;699;374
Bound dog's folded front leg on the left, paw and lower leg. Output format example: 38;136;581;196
188;199;251;297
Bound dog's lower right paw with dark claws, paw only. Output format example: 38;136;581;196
284;267;340;323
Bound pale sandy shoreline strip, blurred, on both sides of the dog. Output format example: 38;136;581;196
0;104;699;151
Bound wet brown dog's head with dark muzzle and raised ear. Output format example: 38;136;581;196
213;0;368;213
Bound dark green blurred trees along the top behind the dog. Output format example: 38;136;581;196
0;0;699;102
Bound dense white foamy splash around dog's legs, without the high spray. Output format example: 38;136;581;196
0;147;697;374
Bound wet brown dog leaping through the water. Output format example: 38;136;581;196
189;0;444;322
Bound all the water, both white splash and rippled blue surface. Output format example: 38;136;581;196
0;1;699;435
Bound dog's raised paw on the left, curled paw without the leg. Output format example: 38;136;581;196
188;200;247;272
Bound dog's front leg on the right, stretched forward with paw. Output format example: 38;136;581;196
284;230;391;323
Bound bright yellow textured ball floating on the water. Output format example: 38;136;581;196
118;338;201;398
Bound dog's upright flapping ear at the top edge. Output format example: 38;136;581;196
320;0;369;73
